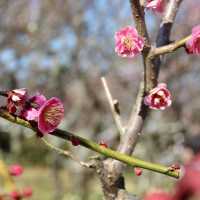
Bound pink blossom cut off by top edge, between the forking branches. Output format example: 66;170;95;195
146;0;165;13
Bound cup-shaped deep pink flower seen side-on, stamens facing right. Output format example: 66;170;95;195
38;97;64;134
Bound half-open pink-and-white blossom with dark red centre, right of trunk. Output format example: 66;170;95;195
144;83;172;110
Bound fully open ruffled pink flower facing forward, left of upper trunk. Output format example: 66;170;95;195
115;26;144;58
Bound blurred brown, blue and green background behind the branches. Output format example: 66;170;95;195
0;0;200;200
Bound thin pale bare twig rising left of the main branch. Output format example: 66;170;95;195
101;77;124;135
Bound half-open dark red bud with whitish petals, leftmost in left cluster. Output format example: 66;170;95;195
7;88;28;114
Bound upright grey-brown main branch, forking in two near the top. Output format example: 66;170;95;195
100;0;182;200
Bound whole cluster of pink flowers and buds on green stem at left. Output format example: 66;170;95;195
7;88;64;134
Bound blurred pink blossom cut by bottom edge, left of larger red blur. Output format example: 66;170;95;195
144;191;173;200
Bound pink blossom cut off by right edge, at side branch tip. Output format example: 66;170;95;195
186;25;200;55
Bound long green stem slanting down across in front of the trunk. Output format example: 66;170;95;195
0;109;179;178
